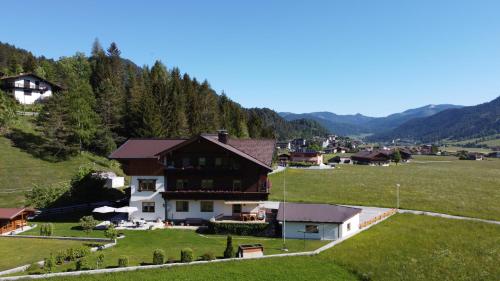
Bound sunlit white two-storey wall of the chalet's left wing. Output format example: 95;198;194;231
129;176;165;221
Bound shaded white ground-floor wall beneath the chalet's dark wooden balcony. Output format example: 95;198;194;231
166;200;259;220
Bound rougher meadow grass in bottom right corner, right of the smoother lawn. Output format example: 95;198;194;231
328;214;500;281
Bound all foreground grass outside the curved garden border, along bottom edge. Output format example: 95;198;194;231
42;214;500;281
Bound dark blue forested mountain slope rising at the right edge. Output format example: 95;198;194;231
371;97;500;142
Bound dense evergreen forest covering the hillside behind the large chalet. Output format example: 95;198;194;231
0;40;327;157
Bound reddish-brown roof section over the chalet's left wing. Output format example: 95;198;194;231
109;139;186;159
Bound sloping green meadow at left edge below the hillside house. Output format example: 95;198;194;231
0;117;122;207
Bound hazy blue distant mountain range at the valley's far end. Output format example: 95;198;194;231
279;104;462;135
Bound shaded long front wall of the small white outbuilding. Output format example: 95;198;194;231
285;222;339;240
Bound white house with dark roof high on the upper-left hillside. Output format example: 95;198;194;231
0;73;62;104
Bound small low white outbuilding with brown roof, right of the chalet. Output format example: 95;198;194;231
277;203;361;240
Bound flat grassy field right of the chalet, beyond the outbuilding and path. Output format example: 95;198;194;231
270;156;500;220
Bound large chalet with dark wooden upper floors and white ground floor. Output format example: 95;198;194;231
109;131;275;222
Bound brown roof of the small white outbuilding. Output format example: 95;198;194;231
277;203;361;223
